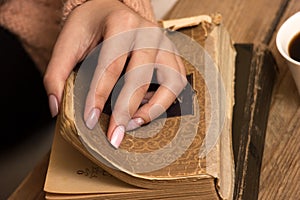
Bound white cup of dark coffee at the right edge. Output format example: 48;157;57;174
276;12;300;94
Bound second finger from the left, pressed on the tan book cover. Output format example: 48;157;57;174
84;19;141;129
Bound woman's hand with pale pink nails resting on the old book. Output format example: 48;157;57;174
44;0;187;148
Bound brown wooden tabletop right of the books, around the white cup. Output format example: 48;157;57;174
166;0;300;200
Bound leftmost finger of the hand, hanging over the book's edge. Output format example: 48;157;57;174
43;19;89;117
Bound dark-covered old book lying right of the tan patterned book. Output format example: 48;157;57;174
232;44;277;199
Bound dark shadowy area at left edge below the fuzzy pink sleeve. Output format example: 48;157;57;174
0;27;55;200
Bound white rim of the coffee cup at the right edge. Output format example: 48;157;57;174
276;11;300;65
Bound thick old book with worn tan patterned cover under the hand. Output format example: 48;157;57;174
44;14;236;199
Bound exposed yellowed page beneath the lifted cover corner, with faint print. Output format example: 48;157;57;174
44;130;143;194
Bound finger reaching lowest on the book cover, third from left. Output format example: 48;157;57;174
107;28;162;148
